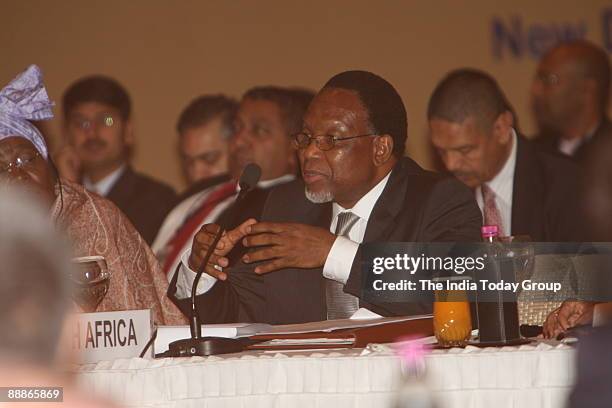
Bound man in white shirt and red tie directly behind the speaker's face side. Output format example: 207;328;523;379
159;86;313;321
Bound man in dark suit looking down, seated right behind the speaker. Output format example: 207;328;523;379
427;69;582;241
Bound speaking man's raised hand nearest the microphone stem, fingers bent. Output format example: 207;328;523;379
189;218;257;280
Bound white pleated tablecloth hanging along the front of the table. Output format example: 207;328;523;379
77;343;575;408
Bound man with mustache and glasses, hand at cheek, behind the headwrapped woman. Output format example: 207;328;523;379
55;76;176;245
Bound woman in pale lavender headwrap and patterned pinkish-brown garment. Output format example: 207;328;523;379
0;65;184;324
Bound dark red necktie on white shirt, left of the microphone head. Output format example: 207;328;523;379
164;181;236;275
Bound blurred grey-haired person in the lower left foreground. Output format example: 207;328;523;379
0;184;117;407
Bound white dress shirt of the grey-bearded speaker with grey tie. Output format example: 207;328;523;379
323;172;391;284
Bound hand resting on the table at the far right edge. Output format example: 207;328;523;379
543;300;595;339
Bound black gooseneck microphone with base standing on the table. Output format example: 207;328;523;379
169;163;261;356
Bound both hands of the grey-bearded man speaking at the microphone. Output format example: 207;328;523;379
189;219;336;280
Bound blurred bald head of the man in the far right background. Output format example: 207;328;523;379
531;40;612;166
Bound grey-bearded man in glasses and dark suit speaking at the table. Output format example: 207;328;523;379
189;71;481;324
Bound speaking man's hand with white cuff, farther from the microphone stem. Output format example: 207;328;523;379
242;222;336;274
